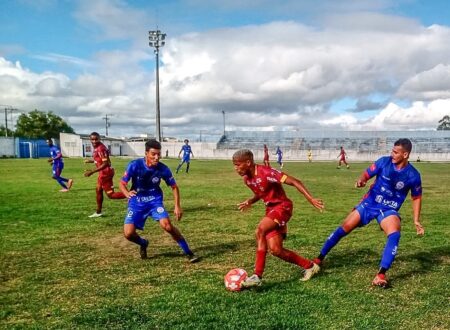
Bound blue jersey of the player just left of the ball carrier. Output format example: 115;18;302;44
122;158;176;205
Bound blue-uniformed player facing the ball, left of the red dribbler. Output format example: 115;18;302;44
119;140;199;263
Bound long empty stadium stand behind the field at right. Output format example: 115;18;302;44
217;130;450;160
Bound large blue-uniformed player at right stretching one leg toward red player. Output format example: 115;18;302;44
313;139;425;288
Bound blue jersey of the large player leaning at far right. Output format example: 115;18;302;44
361;156;422;211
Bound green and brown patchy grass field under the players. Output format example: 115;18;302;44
0;159;450;329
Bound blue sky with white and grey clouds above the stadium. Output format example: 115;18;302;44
0;0;450;140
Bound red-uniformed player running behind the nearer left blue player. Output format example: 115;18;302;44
84;132;125;218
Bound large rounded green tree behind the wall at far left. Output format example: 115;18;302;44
15;110;75;139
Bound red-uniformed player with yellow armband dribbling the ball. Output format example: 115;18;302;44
233;149;324;287
